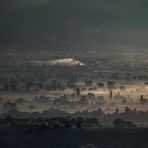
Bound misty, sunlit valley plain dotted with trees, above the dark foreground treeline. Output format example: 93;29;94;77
0;52;148;127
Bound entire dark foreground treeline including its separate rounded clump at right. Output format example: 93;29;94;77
0;115;136;129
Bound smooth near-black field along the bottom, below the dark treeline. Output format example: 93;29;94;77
0;128;148;148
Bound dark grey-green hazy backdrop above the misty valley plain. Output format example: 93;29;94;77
0;0;148;50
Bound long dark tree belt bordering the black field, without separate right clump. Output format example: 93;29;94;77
0;115;100;129
